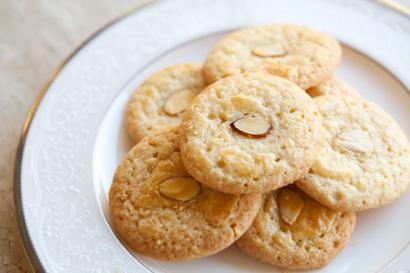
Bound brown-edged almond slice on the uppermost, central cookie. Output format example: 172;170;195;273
229;116;272;138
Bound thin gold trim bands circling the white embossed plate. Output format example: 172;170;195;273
13;0;410;272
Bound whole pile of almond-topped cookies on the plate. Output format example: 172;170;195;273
109;25;410;269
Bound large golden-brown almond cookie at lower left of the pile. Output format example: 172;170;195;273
109;125;261;261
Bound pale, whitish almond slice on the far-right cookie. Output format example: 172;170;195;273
335;129;374;153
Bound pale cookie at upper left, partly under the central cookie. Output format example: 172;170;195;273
126;64;205;142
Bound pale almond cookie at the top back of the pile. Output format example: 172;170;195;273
204;25;342;89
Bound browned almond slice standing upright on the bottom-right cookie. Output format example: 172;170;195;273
278;188;305;225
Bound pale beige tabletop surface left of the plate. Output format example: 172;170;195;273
0;0;140;273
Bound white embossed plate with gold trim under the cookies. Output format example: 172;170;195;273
15;0;410;273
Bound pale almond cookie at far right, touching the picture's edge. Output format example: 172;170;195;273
296;95;410;211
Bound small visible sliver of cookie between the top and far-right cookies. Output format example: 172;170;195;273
306;77;360;97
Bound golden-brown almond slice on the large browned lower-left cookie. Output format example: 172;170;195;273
159;177;201;201
